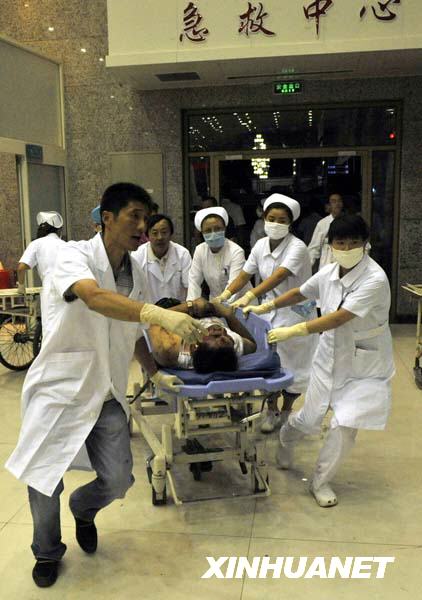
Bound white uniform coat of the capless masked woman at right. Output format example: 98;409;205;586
291;255;394;433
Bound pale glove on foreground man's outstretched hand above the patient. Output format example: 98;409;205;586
139;304;207;344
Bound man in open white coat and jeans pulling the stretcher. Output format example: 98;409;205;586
6;183;203;587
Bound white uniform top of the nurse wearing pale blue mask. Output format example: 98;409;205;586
187;238;251;300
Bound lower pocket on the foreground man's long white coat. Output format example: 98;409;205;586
41;350;95;404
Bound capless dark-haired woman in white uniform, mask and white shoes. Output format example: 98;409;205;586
260;215;394;507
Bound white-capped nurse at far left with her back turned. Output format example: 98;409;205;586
17;211;66;338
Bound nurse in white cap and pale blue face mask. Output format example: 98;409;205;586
187;206;251;300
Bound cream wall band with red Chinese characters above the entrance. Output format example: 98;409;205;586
107;0;422;66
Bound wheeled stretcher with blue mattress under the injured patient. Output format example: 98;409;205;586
131;310;293;505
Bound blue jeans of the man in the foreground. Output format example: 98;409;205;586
28;400;135;560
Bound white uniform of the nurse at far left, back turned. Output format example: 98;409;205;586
19;233;66;336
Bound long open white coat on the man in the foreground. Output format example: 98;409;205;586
6;234;145;496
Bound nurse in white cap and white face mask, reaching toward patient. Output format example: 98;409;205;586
219;194;317;433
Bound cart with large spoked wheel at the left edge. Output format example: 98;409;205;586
0;287;42;371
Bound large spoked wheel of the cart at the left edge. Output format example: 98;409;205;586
0;316;37;371
